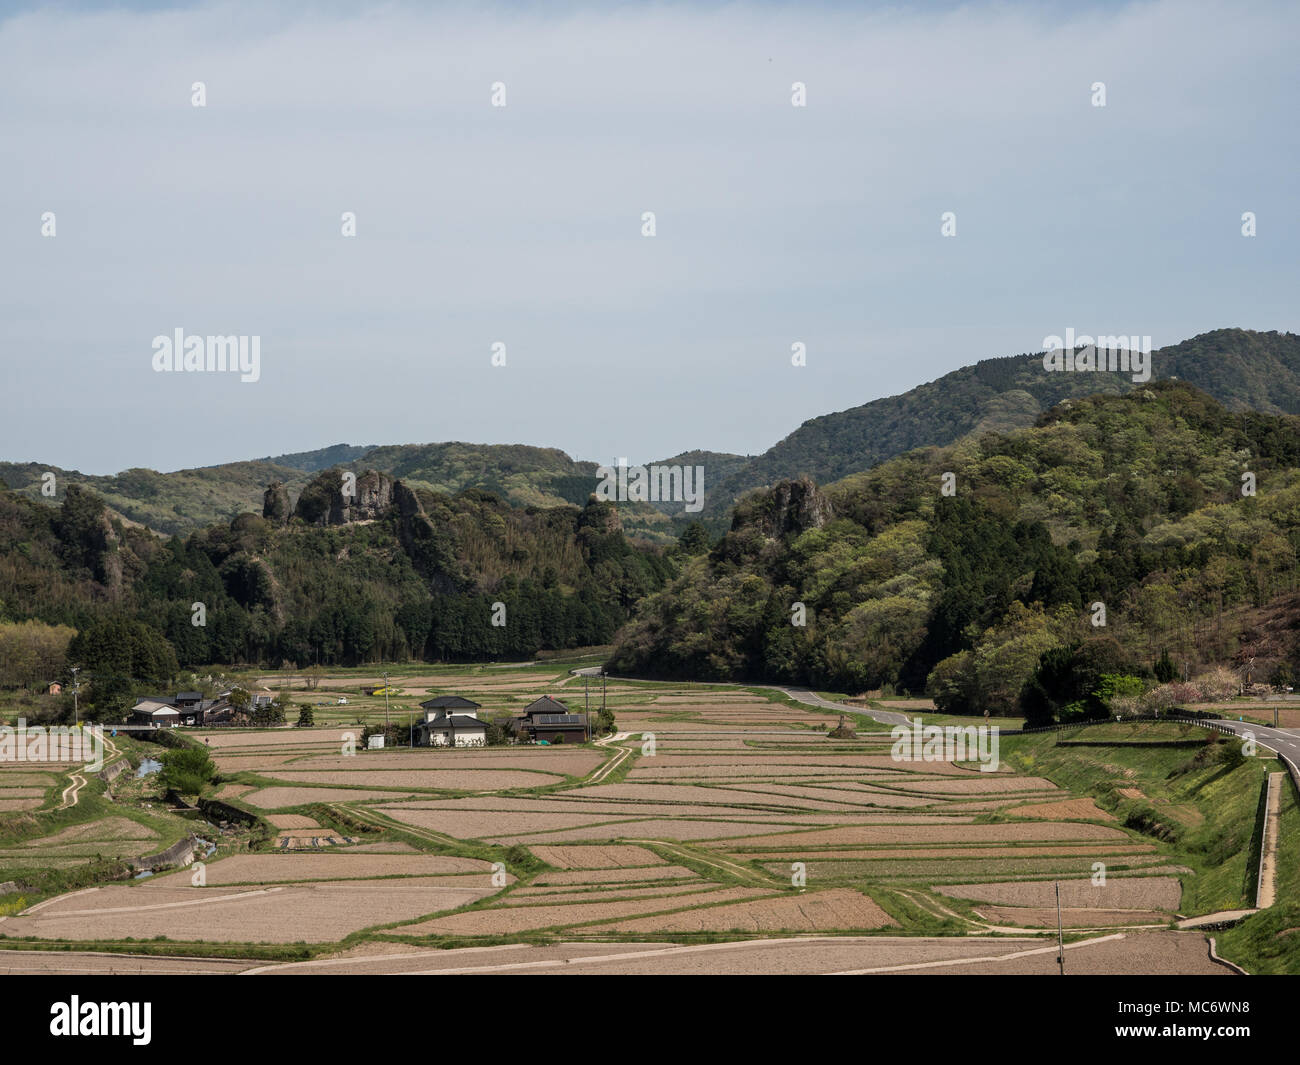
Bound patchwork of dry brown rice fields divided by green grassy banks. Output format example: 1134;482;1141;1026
0;667;1237;971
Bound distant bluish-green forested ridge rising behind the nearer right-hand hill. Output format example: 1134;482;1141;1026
709;329;1300;511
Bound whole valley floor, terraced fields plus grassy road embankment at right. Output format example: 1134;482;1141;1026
0;664;1300;974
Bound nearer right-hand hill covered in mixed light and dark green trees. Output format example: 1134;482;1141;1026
611;381;1300;714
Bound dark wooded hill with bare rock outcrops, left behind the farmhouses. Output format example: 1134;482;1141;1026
0;471;671;717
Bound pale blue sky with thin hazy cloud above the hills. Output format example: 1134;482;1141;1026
0;0;1300;473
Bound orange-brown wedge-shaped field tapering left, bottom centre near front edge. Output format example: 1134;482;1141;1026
584;888;897;935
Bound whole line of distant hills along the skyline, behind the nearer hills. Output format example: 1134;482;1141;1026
0;329;1300;544
